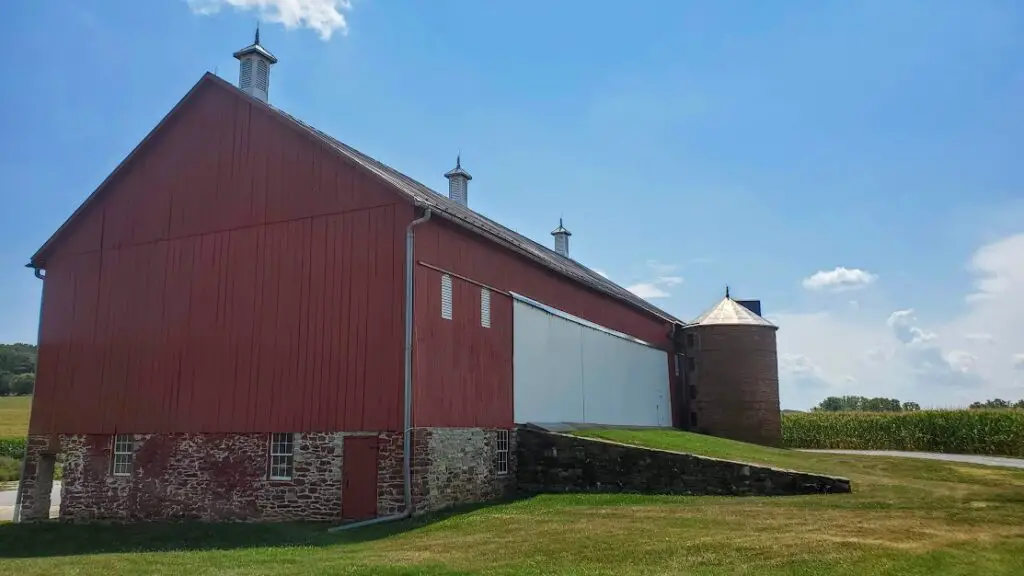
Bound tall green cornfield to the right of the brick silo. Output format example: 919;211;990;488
782;410;1024;456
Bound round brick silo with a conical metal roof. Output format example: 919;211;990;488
683;289;782;446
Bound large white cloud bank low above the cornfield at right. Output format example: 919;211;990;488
773;229;1024;408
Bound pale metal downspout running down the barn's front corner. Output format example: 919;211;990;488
328;204;431;532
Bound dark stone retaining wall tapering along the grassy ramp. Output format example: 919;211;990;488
517;427;850;496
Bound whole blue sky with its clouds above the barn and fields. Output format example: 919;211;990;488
0;0;1024;408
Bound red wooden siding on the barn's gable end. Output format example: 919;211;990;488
30;82;412;434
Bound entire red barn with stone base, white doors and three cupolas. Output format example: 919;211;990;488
22;37;774;521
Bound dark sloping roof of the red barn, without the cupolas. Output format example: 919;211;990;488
29;73;683;324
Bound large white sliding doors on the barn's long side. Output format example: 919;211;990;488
512;295;672;426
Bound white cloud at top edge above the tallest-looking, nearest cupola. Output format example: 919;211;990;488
185;0;352;40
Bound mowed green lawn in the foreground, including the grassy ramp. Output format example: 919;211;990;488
6;430;1024;576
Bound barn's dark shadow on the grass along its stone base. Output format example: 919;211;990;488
0;499;513;559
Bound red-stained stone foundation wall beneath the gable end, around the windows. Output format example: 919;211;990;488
48;433;401;521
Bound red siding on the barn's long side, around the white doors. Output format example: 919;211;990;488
414;218;678;426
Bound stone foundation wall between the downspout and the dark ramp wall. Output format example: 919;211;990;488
413;428;516;513
